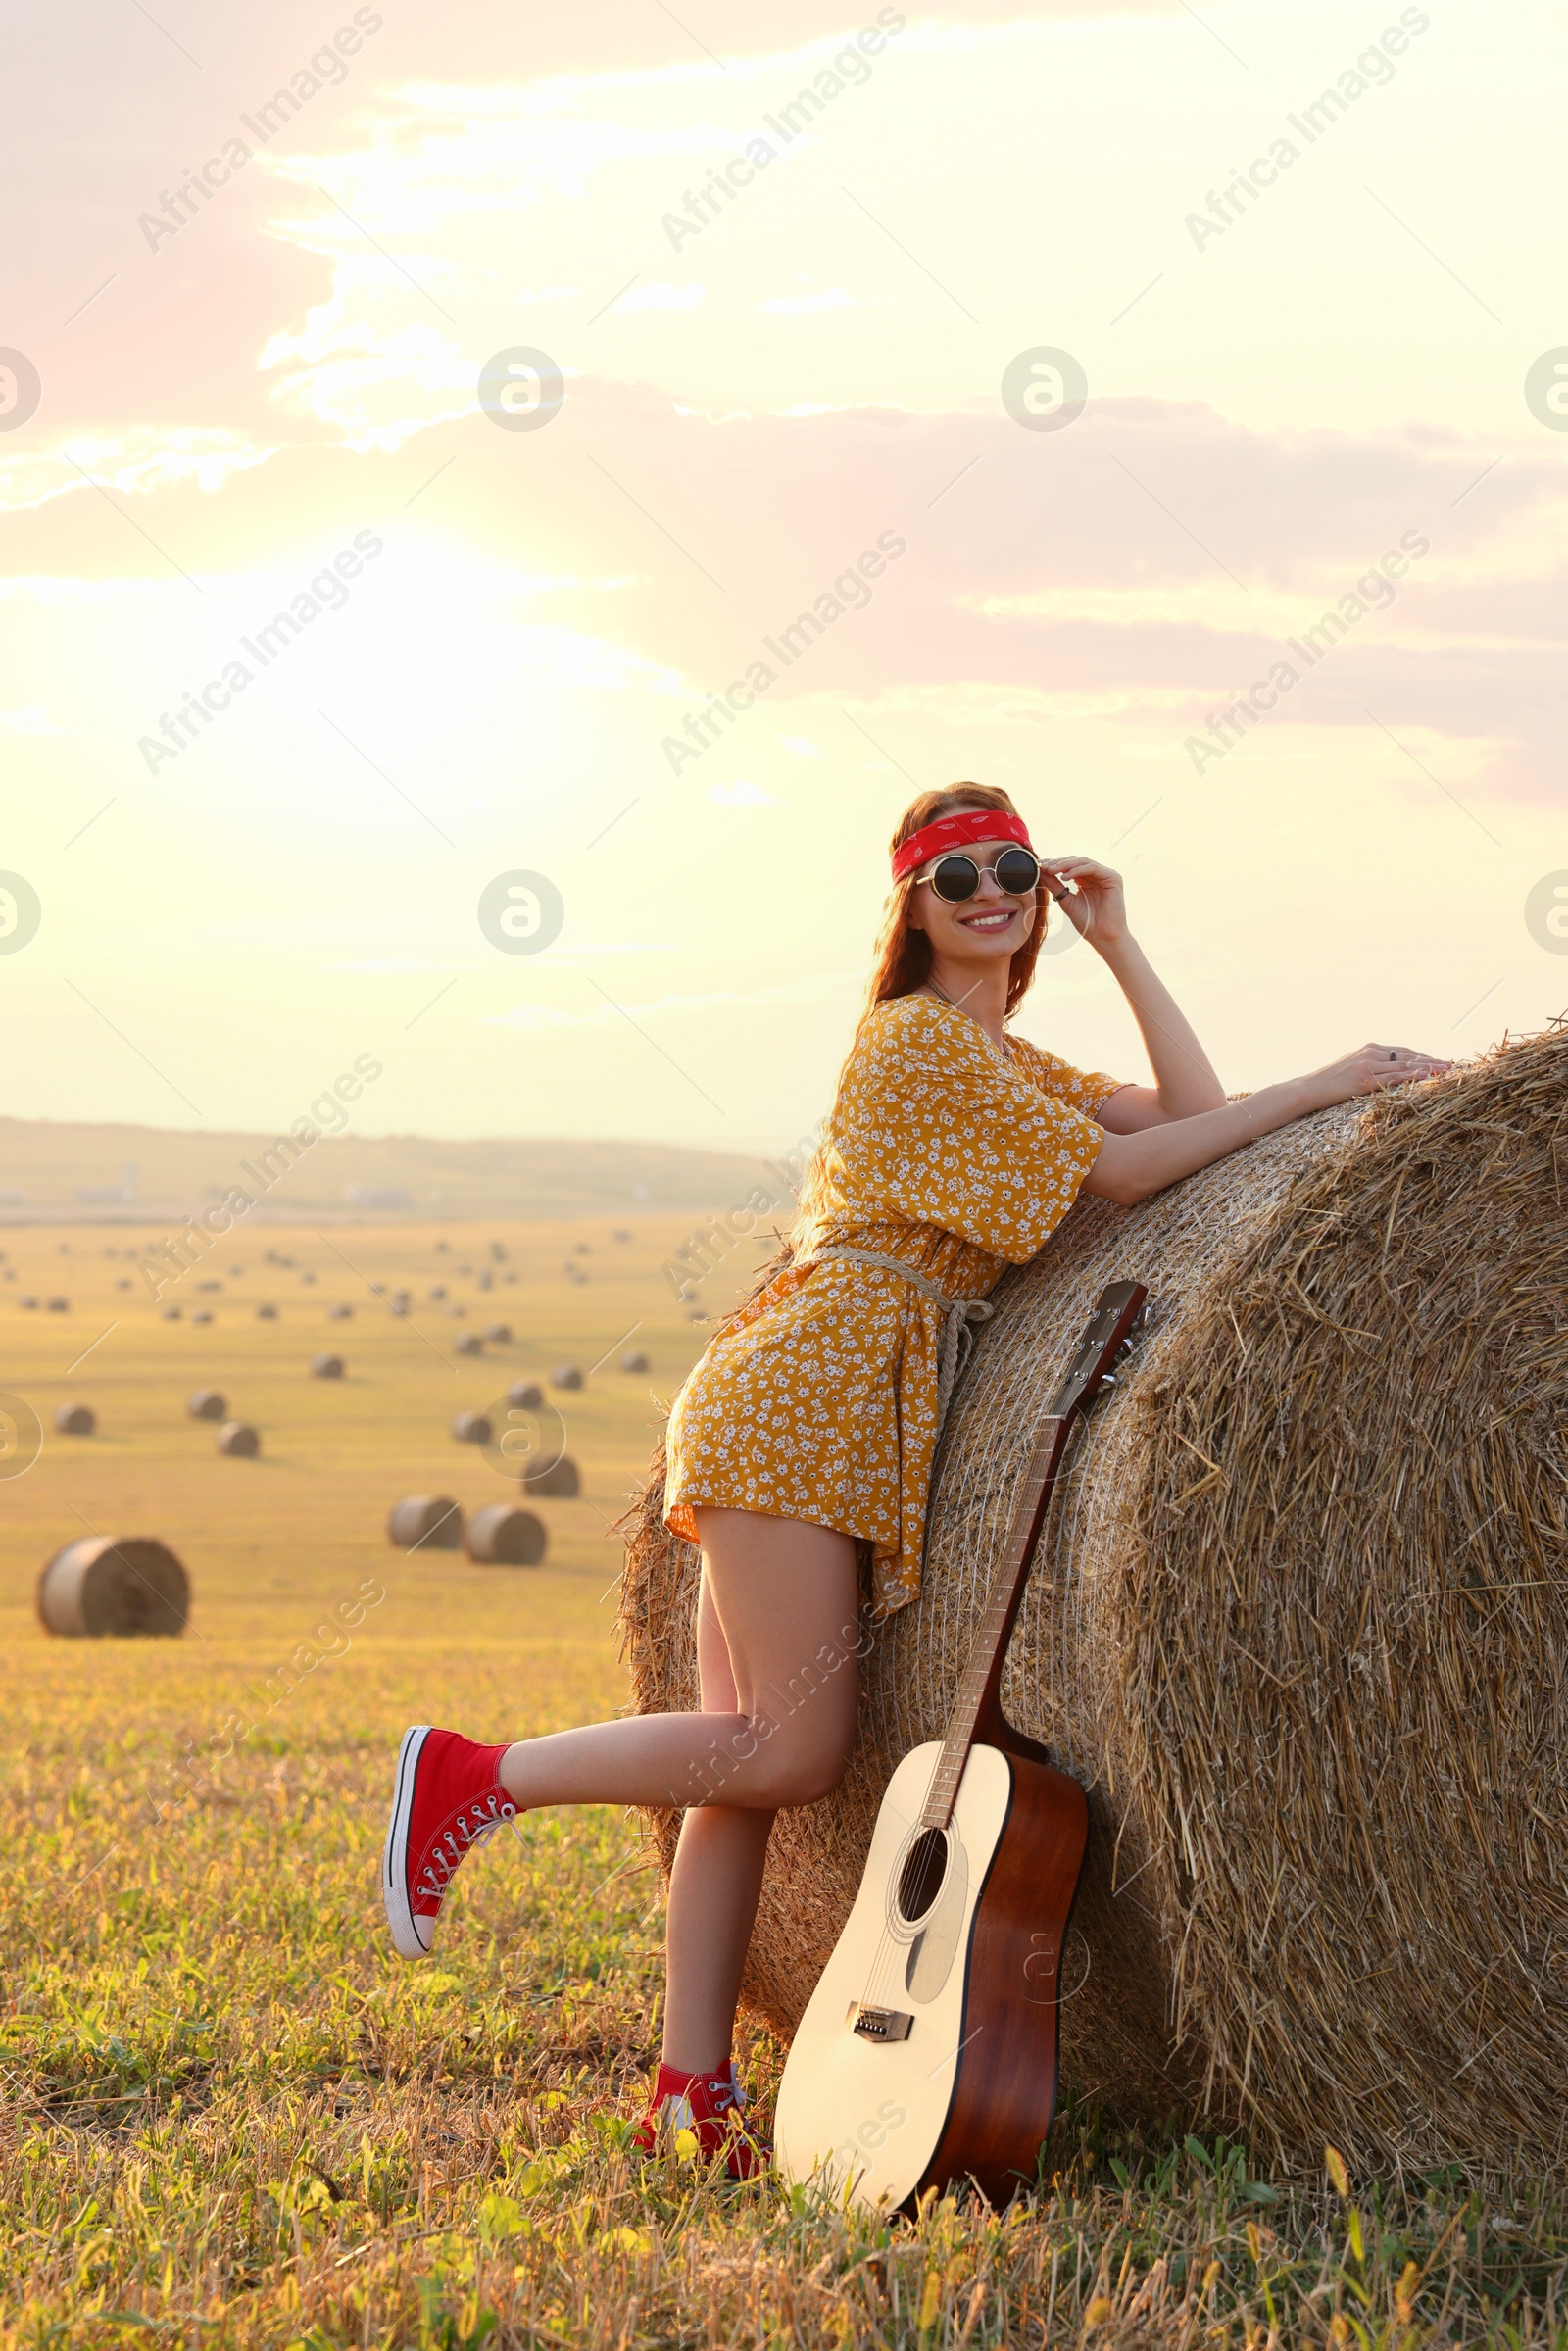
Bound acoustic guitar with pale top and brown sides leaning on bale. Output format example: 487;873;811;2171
773;1281;1148;2210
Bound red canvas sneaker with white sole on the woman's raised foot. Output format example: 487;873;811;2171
381;1723;517;1958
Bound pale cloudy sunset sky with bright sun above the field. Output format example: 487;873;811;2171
0;0;1568;1152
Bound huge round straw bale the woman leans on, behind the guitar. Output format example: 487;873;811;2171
623;1027;1568;2173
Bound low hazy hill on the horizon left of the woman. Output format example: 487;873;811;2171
0;1119;789;1225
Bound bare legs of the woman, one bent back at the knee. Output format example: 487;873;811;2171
501;1509;860;2074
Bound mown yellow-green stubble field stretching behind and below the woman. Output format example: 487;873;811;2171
0;1225;1568;2351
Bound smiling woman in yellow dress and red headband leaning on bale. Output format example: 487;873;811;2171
385;783;1448;2177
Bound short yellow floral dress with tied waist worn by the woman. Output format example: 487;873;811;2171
665;995;1121;1618
